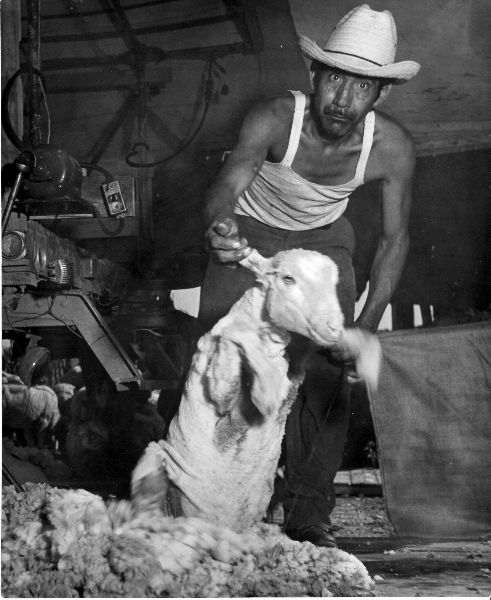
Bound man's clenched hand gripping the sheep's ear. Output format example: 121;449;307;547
205;217;252;266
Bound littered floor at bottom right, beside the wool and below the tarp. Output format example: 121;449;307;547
332;496;491;598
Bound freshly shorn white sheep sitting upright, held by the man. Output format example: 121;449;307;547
131;249;381;531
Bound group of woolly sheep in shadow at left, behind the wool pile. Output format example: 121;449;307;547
2;366;165;481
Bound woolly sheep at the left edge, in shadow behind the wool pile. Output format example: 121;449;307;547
2;371;60;448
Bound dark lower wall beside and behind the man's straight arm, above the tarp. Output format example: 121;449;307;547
347;150;491;325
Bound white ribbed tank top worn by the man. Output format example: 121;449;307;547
235;91;375;231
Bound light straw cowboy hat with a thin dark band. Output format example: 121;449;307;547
299;4;421;83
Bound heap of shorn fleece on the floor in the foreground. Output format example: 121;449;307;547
2;484;373;598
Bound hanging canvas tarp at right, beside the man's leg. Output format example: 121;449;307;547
371;322;491;538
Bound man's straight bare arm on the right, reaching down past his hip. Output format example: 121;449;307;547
356;129;415;332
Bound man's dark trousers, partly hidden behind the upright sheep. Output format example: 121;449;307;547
198;216;356;529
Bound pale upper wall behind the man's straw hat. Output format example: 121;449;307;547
290;0;491;156
